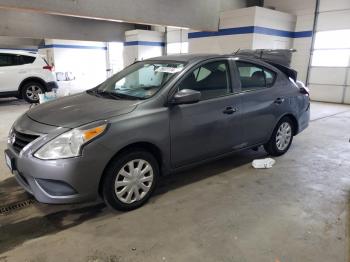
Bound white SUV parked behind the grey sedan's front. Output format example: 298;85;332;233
0;50;58;103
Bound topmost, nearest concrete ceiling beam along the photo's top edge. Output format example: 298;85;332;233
0;0;221;31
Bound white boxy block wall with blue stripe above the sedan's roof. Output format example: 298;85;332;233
189;6;296;54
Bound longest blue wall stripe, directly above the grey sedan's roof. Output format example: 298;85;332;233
188;26;312;38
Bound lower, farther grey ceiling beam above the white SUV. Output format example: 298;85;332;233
0;9;135;42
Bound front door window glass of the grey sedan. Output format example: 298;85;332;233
179;61;231;100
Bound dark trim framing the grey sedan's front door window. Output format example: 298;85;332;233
168;57;236;103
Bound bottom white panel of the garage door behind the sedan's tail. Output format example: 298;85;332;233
309;84;344;103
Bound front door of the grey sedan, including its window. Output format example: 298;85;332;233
169;59;241;168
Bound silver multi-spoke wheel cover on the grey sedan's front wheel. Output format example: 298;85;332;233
114;159;154;204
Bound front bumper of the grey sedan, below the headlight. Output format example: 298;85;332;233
6;147;103;204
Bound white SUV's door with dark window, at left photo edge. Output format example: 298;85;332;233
0;53;21;92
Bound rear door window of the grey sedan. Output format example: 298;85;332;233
236;61;276;91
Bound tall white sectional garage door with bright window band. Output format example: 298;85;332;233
308;0;350;104
